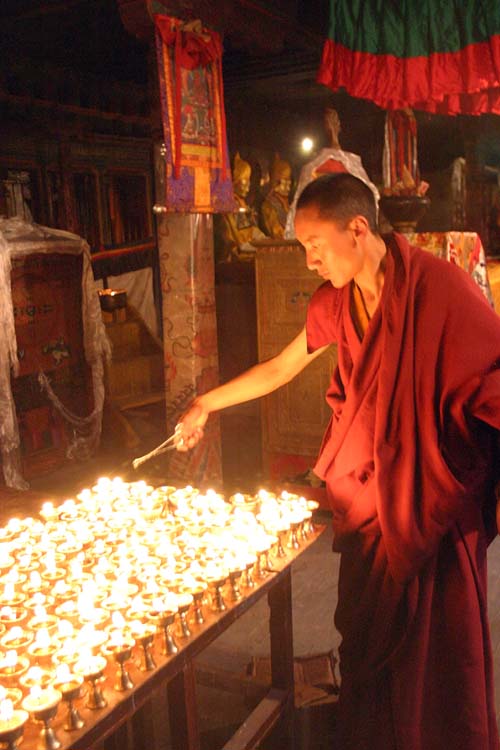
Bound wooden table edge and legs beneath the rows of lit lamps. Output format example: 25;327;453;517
17;526;324;750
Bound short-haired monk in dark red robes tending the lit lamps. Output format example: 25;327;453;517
178;174;500;750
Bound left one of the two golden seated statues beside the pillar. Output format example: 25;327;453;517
216;153;266;262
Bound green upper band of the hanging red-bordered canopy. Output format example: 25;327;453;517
329;0;500;57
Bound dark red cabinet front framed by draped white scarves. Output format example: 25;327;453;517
9;250;93;479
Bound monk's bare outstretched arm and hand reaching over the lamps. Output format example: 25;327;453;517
176;328;327;451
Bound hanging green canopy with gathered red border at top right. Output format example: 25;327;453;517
317;0;500;115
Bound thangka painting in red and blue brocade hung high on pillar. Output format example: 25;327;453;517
155;15;235;213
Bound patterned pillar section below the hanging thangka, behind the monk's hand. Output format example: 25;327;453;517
158;206;222;488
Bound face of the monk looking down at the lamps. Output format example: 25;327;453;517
295;206;364;289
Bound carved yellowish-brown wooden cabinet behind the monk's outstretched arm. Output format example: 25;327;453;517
256;240;337;479
